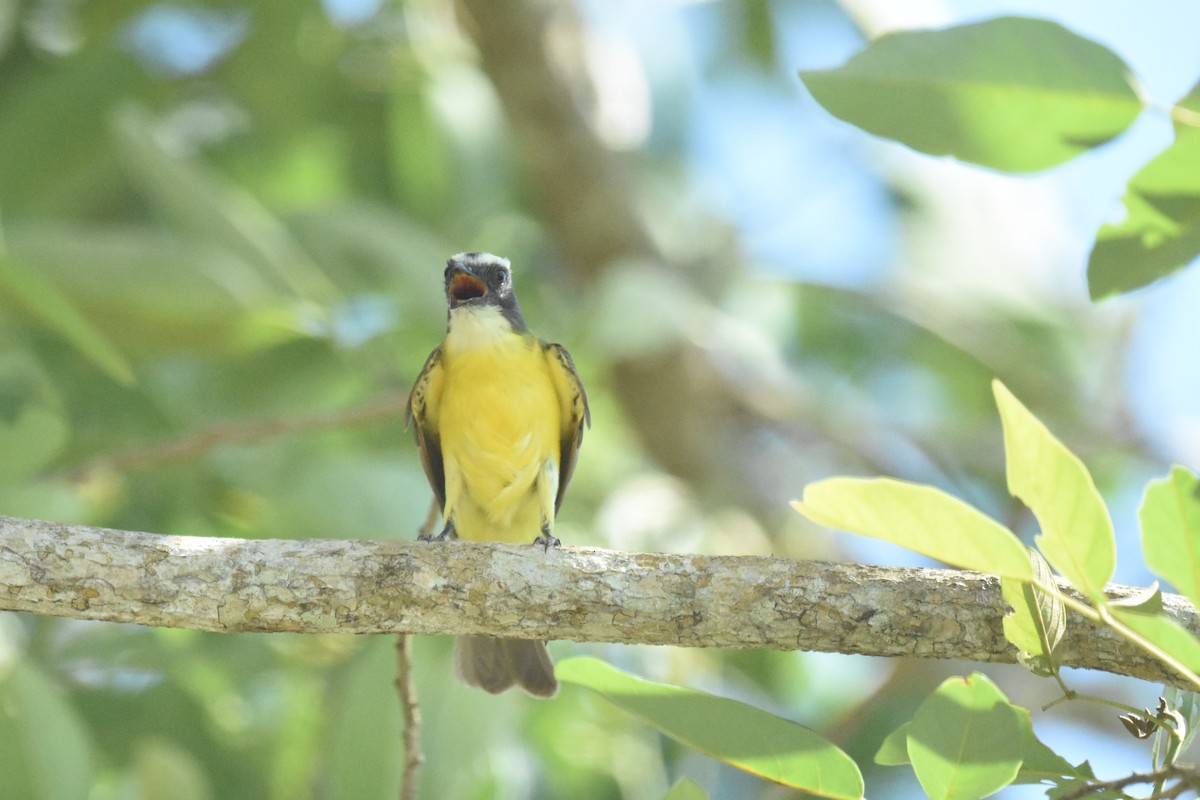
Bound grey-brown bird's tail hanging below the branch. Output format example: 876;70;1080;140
454;636;558;697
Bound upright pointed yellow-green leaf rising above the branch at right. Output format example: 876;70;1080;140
991;380;1117;604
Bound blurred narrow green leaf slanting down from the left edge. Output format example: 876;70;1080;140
0;259;133;386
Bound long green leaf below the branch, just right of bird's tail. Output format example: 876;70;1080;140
556;658;863;798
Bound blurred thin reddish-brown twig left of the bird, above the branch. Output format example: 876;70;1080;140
64;392;408;480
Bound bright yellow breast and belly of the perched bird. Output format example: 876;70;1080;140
438;333;560;542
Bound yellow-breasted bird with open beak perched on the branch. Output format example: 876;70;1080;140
406;253;592;697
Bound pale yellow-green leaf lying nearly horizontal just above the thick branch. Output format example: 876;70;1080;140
792;477;1033;581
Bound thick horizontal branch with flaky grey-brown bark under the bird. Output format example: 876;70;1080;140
0;517;1198;685
